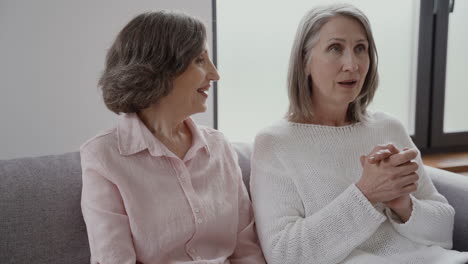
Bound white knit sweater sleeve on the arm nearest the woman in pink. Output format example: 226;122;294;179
251;134;386;264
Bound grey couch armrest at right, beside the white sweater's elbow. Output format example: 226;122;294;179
424;166;468;251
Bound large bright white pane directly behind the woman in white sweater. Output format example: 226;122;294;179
217;0;420;142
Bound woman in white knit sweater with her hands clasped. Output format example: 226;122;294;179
251;5;468;264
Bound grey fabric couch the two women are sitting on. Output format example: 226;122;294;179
0;143;468;264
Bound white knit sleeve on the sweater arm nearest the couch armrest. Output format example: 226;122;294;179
385;119;455;249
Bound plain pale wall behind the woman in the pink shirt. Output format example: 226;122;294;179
0;0;213;159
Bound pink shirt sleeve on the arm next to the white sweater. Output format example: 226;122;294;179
229;142;265;264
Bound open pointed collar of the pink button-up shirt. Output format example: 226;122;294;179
117;113;210;160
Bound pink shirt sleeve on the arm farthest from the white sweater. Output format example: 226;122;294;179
81;149;136;264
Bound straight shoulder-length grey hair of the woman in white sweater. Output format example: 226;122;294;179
286;4;379;122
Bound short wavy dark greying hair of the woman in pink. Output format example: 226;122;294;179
98;11;206;114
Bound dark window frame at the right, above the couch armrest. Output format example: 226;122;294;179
413;0;468;153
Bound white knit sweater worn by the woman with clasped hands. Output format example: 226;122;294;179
250;113;468;264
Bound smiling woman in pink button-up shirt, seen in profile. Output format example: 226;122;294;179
80;11;265;264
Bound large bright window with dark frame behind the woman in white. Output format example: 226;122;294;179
213;0;468;151
